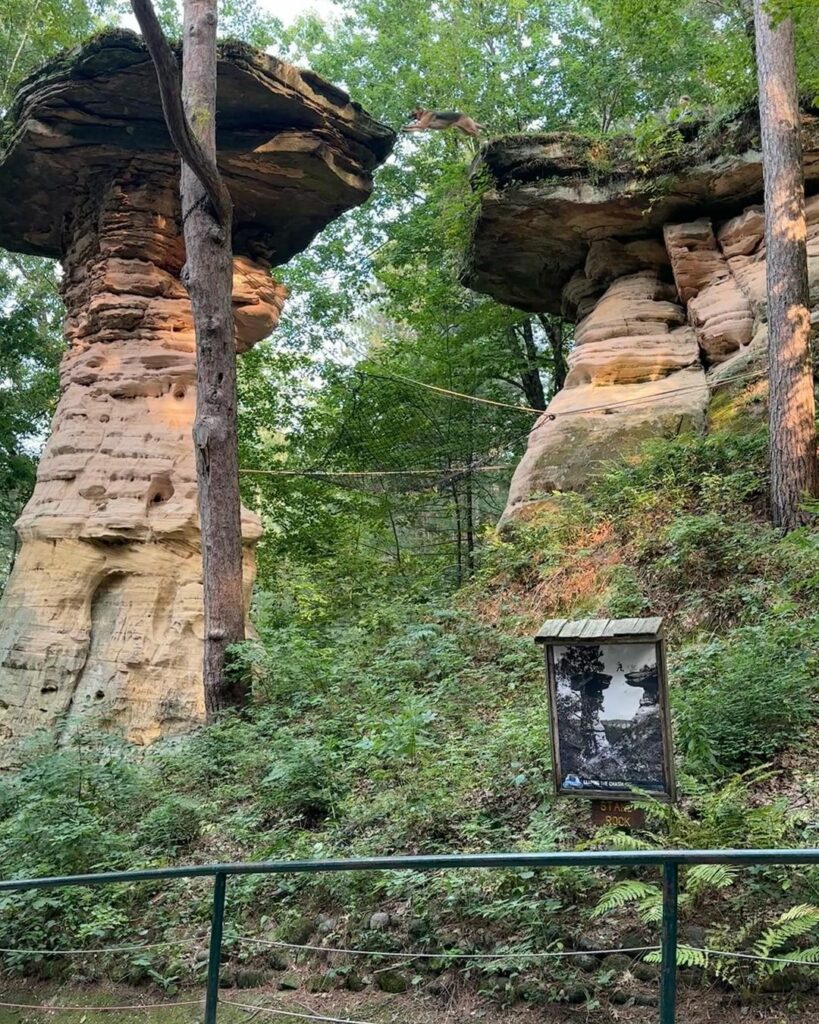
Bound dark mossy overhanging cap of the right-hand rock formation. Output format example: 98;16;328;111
462;106;819;313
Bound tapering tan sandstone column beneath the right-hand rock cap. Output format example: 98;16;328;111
504;256;708;518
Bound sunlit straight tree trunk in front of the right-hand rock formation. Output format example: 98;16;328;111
753;0;817;529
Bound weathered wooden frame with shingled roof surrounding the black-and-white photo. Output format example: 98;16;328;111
535;617;677;803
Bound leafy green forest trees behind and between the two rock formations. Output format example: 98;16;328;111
0;0;819;593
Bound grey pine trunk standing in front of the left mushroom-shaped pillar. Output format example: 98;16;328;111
181;0;247;720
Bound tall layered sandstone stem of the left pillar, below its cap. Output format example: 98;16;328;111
0;161;284;763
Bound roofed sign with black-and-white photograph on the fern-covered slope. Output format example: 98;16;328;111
535;618;675;801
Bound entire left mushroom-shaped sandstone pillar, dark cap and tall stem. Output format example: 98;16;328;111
0;32;393;763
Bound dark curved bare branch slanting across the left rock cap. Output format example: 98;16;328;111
131;0;232;228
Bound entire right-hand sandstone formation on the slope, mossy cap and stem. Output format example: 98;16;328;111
464;112;819;518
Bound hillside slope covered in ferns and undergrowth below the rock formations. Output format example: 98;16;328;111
0;385;819;1011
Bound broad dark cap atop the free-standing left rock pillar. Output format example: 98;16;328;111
0;30;395;264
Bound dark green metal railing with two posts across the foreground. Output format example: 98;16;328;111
0;849;819;1024
